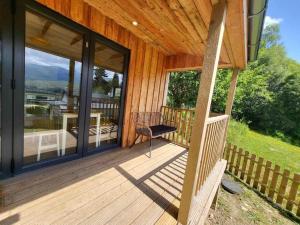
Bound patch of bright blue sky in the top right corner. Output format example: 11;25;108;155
265;0;300;63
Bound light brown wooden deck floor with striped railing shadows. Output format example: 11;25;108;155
0;140;187;225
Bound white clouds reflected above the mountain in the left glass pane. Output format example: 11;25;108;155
25;47;70;70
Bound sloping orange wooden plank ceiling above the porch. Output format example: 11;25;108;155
84;0;247;68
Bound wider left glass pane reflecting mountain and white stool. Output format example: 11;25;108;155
23;11;83;165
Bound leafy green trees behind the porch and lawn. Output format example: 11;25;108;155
168;24;300;145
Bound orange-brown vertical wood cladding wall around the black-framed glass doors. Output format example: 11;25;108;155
38;0;166;147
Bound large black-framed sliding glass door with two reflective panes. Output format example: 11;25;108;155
11;1;129;172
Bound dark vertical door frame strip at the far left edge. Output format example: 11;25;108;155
0;0;13;178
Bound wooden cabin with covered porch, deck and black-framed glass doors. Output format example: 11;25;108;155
0;0;266;225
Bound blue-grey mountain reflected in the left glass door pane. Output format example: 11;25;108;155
25;64;69;81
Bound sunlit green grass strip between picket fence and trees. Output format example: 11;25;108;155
227;120;300;173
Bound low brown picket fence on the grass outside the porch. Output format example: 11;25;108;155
224;144;300;216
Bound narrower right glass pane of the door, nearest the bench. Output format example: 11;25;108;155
88;41;125;150
